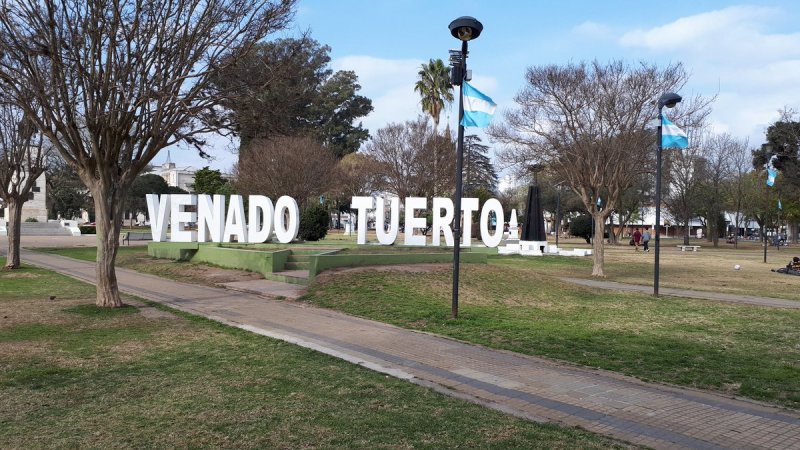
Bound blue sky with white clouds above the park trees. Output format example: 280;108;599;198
159;0;800;175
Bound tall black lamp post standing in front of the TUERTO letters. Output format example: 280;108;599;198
448;16;483;319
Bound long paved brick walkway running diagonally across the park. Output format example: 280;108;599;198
15;251;800;449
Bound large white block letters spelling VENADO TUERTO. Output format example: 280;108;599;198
147;194;504;247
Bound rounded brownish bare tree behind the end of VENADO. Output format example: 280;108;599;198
234;137;336;209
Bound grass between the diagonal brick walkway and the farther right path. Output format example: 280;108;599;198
301;264;800;408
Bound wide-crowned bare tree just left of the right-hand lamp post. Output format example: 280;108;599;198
489;61;710;277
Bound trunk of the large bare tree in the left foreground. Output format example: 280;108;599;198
92;189;124;308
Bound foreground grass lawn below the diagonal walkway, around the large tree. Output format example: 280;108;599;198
0;256;617;449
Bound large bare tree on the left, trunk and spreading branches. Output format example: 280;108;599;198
0;0;295;307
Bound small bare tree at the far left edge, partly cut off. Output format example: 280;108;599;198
0;97;47;269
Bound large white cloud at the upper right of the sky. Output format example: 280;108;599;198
617;6;800;145
